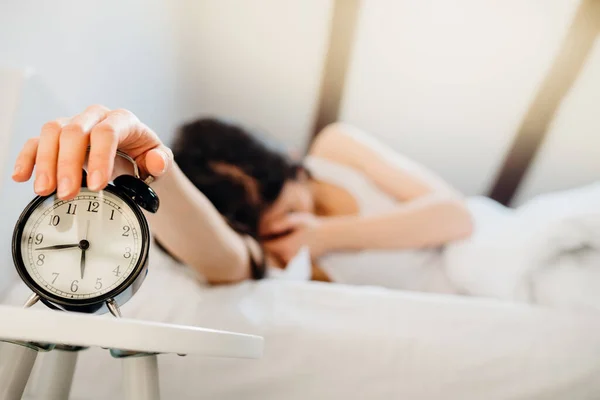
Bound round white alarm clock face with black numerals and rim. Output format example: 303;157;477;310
15;188;147;302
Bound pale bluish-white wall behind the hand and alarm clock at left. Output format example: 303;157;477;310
0;0;181;289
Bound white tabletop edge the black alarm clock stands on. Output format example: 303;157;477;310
0;306;263;358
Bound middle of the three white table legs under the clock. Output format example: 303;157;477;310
36;350;78;400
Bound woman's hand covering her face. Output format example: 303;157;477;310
264;213;326;265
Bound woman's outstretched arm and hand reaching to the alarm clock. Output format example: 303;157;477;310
13;105;253;283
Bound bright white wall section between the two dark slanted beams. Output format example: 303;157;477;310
342;0;584;195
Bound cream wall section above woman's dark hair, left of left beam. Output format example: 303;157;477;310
175;0;332;147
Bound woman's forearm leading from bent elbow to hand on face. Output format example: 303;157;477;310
317;195;472;253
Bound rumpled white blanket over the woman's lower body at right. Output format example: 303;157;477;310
445;184;600;310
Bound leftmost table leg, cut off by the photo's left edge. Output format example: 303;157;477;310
0;342;38;400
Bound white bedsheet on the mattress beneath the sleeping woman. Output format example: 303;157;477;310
7;247;600;400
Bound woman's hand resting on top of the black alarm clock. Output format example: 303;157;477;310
13;105;172;200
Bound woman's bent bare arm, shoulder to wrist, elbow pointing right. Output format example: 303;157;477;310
311;124;472;252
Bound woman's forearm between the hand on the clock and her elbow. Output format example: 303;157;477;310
148;165;249;283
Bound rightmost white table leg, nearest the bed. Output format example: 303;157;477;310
122;354;160;400
